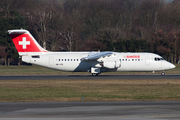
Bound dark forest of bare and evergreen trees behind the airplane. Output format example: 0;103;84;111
0;0;180;65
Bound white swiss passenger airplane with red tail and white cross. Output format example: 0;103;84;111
8;29;175;76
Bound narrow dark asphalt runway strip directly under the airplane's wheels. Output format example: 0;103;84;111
0;74;180;80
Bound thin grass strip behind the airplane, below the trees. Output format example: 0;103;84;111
0;64;180;75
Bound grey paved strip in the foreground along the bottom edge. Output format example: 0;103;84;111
0;101;180;120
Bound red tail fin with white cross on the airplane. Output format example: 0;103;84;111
8;29;48;56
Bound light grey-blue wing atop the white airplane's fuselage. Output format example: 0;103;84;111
82;52;113;60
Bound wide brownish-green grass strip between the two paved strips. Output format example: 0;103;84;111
0;80;180;102
